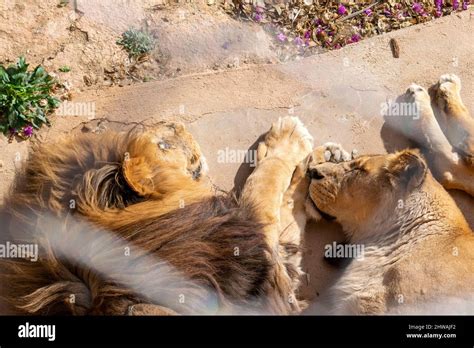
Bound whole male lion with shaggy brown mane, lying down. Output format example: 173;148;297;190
0;117;340;315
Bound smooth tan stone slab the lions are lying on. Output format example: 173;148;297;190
0;9;474;312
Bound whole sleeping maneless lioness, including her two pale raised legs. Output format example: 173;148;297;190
308;75;474;314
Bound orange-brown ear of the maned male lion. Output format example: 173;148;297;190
122;157;155;196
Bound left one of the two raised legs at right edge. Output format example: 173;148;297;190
406;84;474;196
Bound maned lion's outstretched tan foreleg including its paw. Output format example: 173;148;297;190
241;117;313;313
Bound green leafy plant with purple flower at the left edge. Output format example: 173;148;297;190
0;57;60;138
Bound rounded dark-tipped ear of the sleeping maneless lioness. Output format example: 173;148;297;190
388;149;428;188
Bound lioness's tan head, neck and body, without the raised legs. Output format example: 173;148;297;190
310;150;474;314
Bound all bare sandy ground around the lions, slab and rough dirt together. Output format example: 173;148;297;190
0;0;474;313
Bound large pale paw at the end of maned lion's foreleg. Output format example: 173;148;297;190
257;116;313;166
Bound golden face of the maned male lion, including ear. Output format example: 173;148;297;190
123;122;208;195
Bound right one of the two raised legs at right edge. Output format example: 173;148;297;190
433;74;474;167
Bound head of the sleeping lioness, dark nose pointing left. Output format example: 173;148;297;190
307;150;427;238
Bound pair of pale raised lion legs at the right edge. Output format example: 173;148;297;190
406;75;474;196
